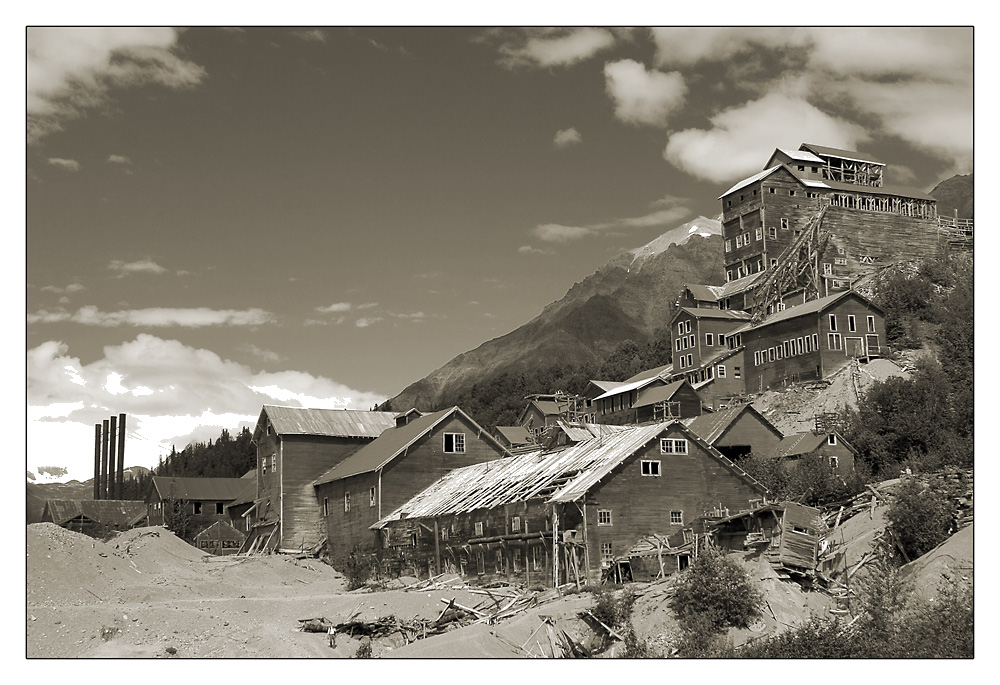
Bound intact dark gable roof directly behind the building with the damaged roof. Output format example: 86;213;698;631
313;407;510;485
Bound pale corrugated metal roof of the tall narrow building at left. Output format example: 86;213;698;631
254;404;397;438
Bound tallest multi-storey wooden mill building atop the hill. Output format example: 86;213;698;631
719;143;937;284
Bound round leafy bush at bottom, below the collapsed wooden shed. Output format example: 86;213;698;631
671;548;763;636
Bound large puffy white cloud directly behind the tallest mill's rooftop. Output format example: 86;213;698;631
663;93;868;183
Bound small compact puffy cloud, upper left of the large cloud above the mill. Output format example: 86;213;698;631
604;59;687;126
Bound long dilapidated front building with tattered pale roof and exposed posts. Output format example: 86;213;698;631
372;421;765;586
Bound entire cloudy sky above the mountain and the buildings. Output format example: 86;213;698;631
24;26;973;480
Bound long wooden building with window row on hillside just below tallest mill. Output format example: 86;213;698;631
727;290;886;393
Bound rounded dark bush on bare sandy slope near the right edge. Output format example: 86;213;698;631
886;478;954;560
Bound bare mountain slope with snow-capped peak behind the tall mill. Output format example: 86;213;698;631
384;217;725;411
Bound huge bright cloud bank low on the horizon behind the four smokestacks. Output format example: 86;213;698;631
27;334;385;479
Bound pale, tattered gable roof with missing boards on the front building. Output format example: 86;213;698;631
371;421;766;529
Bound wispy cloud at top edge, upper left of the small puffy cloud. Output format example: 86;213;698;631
490;28;615;68
